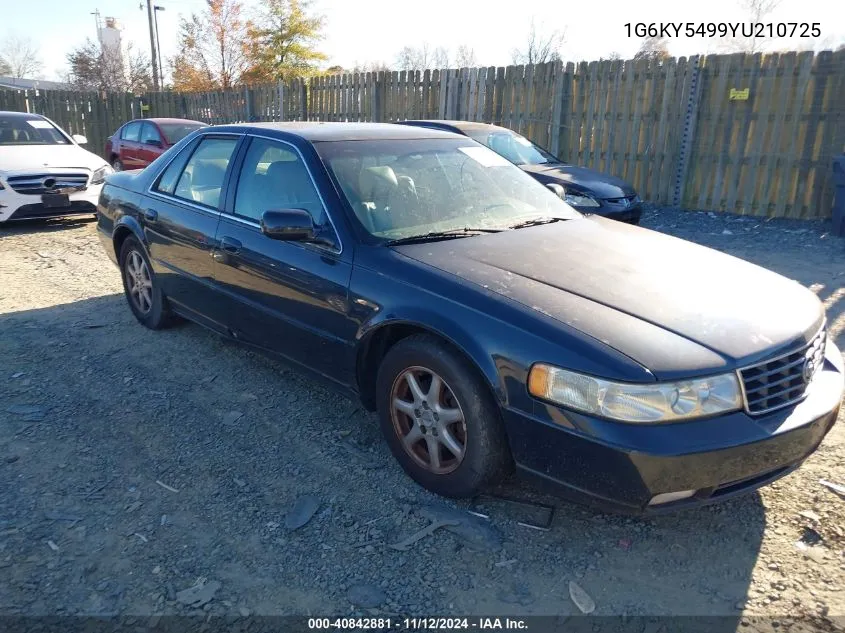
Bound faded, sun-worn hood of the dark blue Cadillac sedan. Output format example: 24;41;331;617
394;217;824;374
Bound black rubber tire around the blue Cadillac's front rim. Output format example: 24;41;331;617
376;334;512;498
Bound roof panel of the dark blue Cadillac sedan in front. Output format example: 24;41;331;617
205;121;458;143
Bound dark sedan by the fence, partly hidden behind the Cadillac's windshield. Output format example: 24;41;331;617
399;120;642;224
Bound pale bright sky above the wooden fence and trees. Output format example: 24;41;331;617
0;0;845;80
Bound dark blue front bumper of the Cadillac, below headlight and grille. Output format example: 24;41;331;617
504;343;845;514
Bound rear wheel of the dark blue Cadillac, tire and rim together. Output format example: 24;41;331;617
120;237;172;330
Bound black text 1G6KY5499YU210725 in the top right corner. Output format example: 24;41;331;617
622;22;822;38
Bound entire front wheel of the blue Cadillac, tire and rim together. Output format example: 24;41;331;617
377;335;511;497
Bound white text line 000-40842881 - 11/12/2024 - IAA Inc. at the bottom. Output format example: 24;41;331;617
308;617;528;631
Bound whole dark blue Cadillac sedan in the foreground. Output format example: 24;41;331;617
98;123;843;513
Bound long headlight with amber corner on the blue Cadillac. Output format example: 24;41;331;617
528;363;742;423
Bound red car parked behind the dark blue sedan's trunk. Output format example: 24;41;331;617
105;119;207;171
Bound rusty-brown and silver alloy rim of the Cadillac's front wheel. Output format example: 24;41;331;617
390;367;467;475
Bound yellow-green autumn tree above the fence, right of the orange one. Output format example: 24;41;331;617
244;0;326;83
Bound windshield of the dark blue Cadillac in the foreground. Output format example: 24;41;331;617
315;139;580;240
